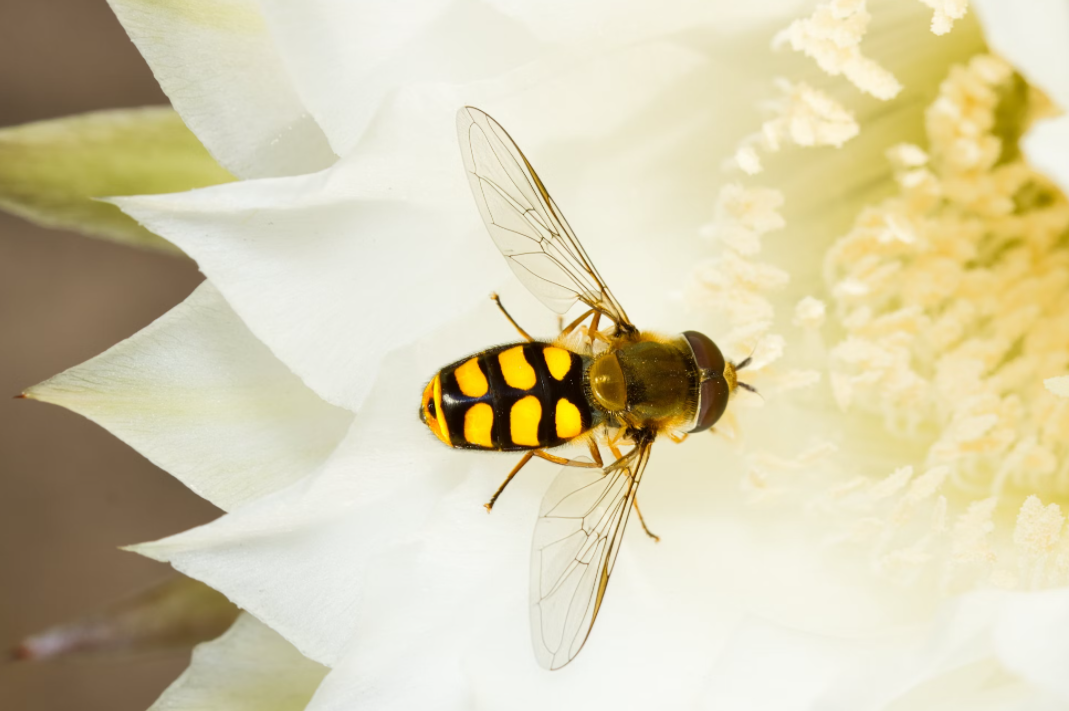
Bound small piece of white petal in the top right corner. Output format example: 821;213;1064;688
972;0;1069;109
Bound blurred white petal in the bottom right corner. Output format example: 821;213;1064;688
808;590;1069;711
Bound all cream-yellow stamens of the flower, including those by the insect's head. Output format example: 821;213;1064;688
696;0;1069;592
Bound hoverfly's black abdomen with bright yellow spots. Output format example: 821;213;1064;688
439;341;592;451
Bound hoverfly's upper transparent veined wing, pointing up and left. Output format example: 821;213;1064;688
456;106;632;326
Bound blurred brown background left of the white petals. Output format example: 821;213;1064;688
0;0;218;711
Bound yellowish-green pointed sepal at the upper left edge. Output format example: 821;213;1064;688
0;107;234;252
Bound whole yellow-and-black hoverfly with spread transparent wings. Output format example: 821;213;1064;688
420;107;750;669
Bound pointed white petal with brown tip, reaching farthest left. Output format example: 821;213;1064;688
27;282;352;509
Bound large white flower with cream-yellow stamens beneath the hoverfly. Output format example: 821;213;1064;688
6;0;1069;711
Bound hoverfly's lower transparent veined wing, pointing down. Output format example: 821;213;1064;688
531;439;652;669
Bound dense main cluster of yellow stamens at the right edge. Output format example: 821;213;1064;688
825;53;1069;590
